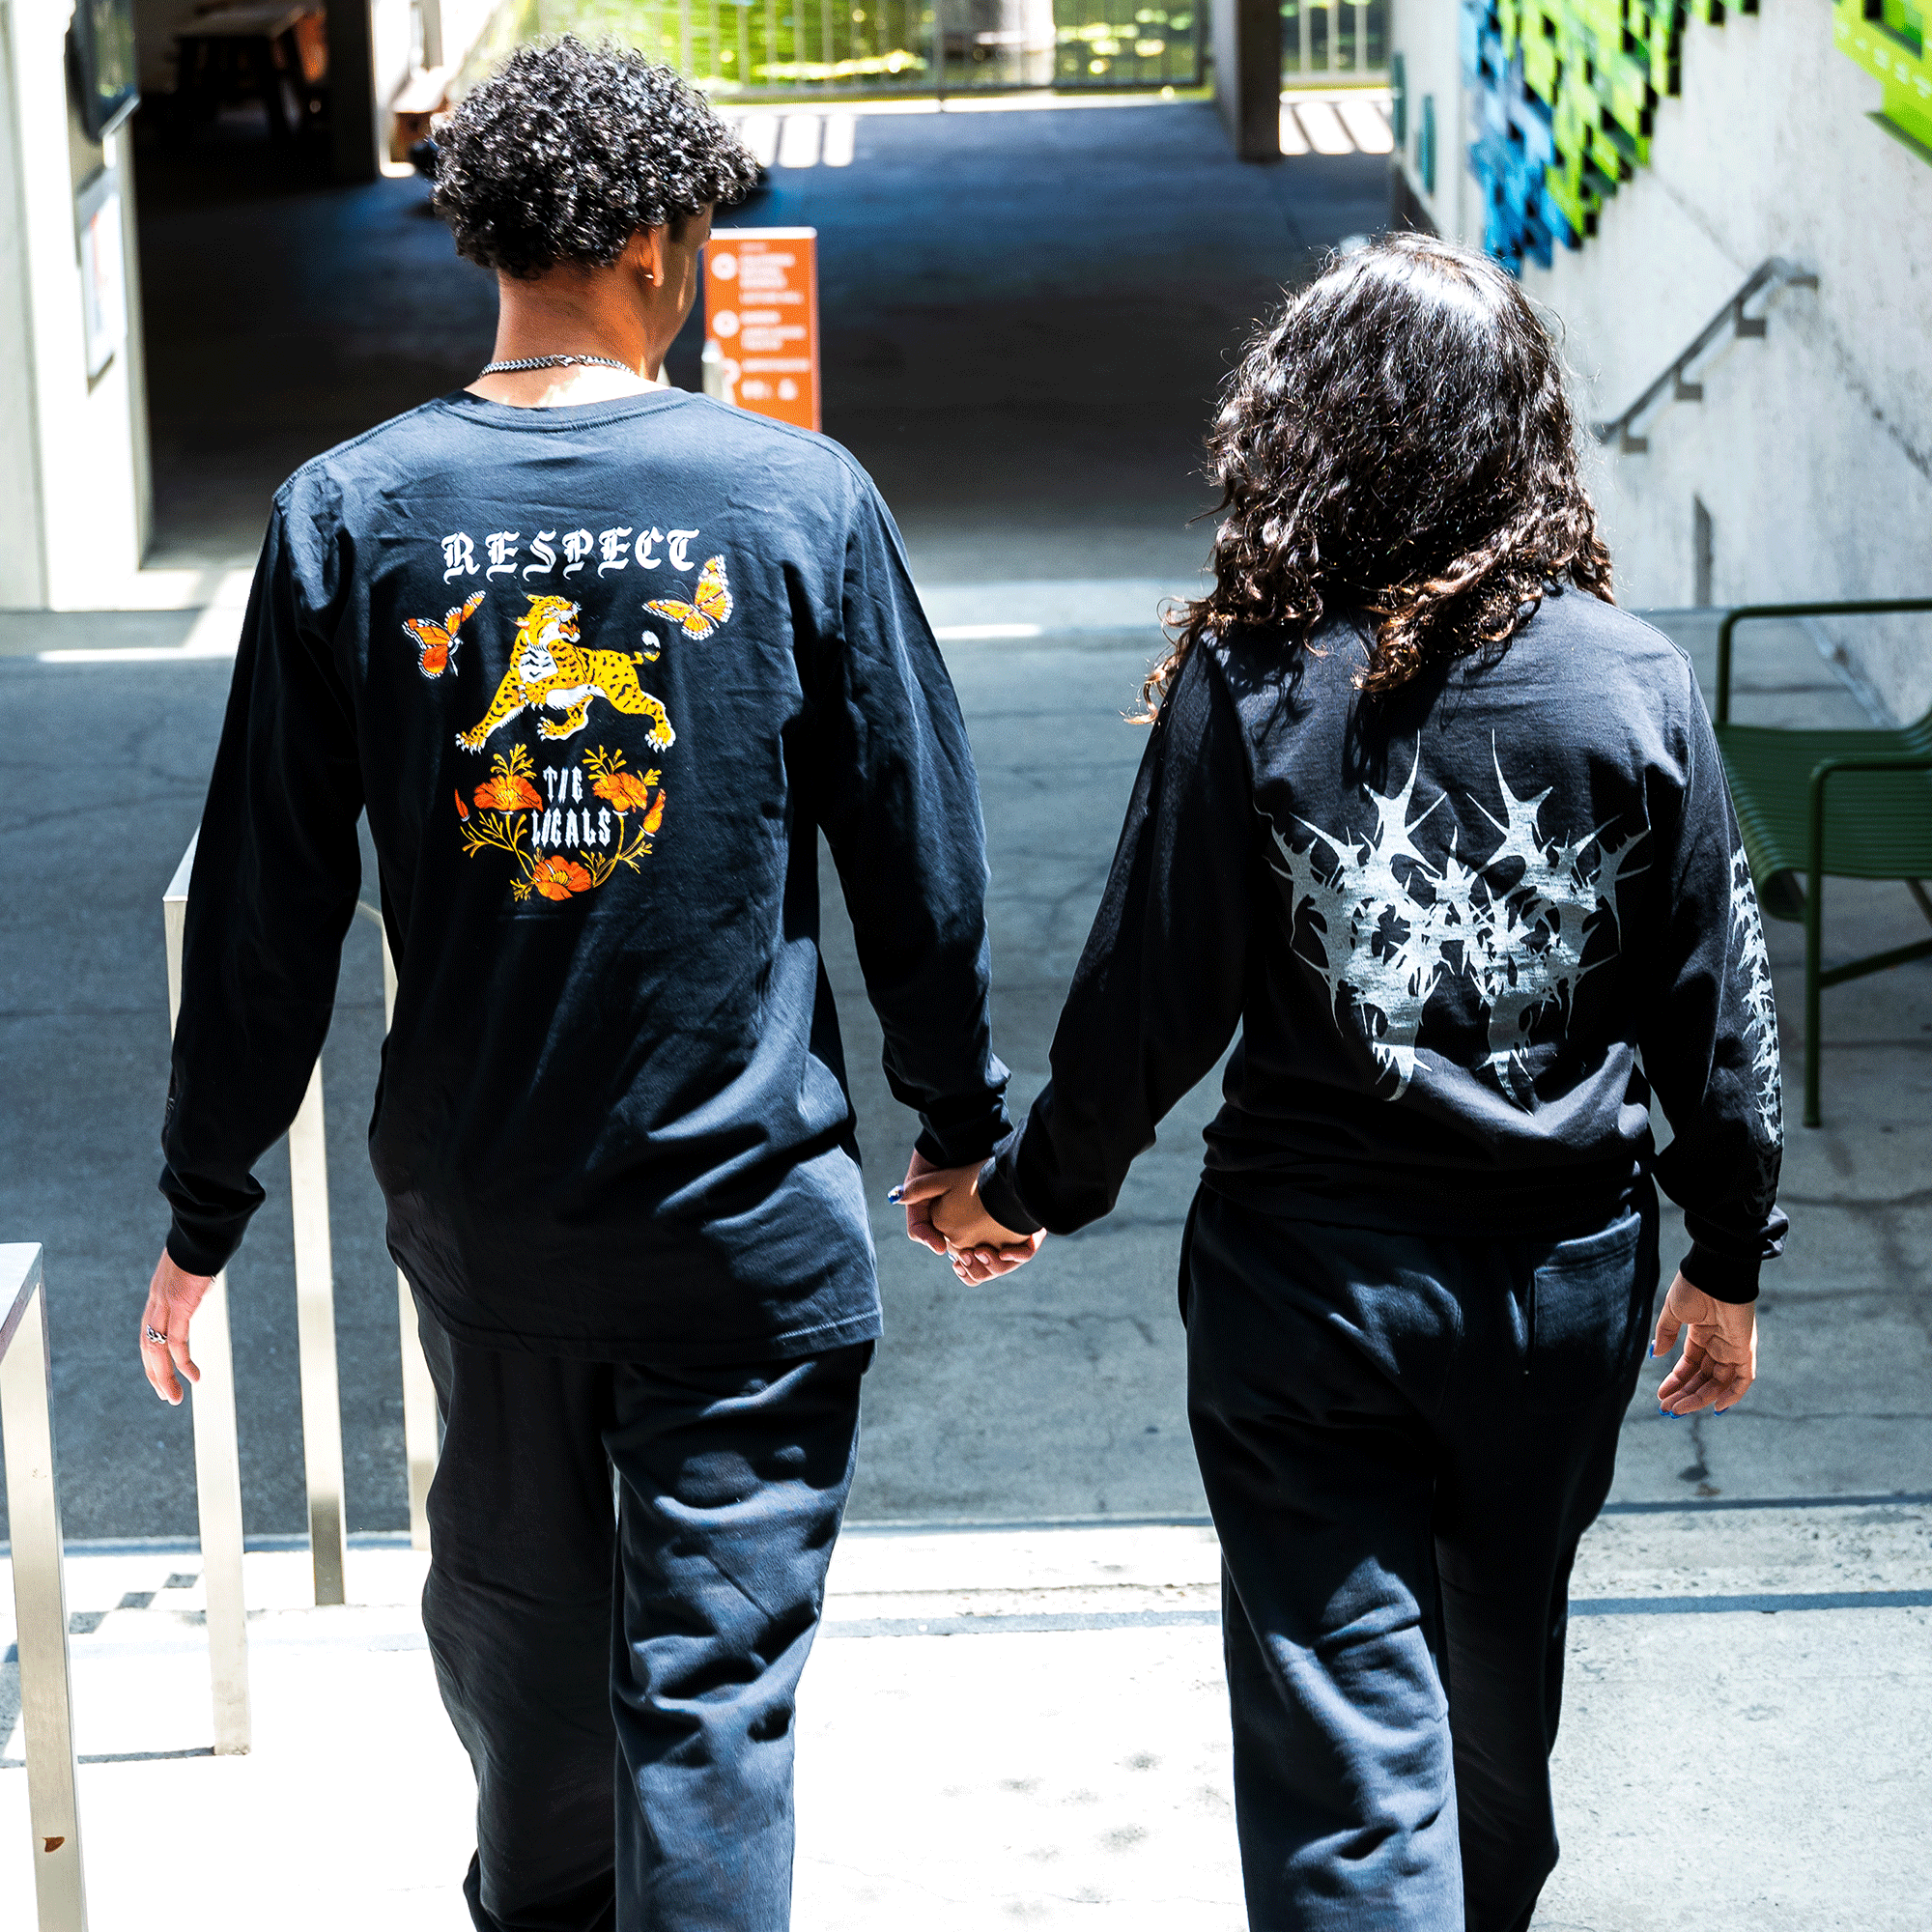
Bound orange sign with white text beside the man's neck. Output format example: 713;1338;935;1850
705;228;819;429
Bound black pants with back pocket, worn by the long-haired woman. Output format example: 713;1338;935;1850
1180;1190;1658;1932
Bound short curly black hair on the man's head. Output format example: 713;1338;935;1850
433;35;757;280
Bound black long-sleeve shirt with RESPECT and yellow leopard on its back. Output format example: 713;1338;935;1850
162;390;1009;1362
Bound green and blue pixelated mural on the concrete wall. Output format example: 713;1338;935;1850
1463;0;1932;269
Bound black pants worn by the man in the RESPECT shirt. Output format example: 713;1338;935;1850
417;1304;871;1932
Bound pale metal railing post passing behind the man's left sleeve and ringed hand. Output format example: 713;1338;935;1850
160;835;249;1756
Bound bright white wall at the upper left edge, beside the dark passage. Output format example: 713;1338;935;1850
0;0;147;609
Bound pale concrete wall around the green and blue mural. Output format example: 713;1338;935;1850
1395;0;1932;717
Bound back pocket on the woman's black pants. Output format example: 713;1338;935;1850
1528;1211;1656;1408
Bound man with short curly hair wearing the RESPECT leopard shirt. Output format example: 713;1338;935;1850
141;30;1007;1932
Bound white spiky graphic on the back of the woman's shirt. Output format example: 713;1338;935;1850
1273;746;1644;1107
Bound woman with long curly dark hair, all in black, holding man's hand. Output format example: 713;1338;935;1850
904;236;1785;1932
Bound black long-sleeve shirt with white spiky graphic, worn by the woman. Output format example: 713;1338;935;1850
981;591;1785;1300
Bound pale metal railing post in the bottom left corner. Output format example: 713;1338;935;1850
0;1242;87;1932
